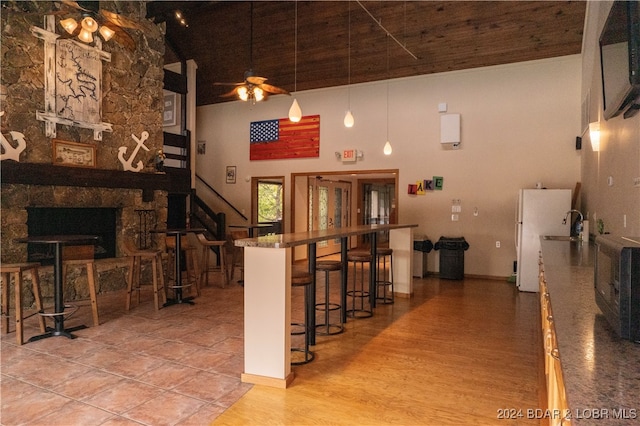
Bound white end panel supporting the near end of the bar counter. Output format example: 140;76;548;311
242;247;293;388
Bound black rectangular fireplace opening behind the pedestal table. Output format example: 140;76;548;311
27;207;118;265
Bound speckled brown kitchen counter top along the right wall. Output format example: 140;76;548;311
541;239;640;425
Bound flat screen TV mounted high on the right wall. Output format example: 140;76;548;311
600;0;640;120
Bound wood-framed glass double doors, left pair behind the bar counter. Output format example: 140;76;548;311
309;177;351;256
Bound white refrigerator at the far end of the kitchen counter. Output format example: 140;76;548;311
515;189;571;292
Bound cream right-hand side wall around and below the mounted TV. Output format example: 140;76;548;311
581;1;640;236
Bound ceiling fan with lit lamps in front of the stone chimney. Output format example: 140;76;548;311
60;0;142;50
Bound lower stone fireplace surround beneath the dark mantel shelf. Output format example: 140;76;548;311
2;182;167;305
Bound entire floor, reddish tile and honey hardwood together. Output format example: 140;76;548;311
0;268;544;426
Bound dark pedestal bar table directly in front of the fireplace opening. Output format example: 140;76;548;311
16;235;98;342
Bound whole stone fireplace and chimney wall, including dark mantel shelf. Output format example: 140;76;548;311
0;2;180;305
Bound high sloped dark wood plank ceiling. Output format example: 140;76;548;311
148;0;586;105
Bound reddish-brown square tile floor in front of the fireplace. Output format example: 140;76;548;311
0;272;252;426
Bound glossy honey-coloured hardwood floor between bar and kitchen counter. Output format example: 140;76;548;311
214;278;541;425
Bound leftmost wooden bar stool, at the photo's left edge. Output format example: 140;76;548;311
0;263;46;345
